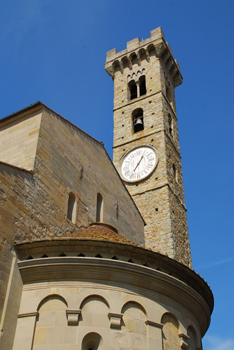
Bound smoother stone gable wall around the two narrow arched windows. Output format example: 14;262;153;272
35;110;144;245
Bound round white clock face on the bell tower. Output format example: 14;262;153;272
121;146;158;182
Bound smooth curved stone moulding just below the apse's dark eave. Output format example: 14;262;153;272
18;257;211;334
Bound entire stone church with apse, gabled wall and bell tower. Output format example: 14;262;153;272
0;28;213;350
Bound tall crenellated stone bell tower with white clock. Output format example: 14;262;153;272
105;27;191;267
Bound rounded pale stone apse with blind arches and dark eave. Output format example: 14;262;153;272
10;235;213;350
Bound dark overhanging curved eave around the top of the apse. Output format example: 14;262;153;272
15;237;213;313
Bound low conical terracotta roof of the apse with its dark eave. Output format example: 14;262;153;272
15;223;213;311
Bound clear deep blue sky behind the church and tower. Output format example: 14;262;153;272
0;0;234;350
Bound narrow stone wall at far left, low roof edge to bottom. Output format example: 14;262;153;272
0;163;35;349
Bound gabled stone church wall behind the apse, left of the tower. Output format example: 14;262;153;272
0;103;144;350
